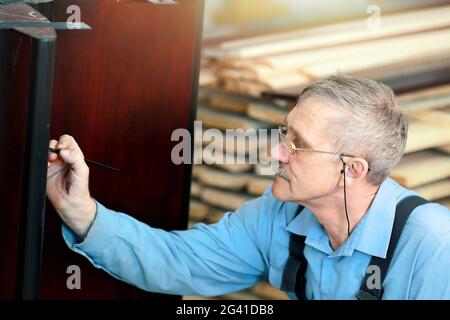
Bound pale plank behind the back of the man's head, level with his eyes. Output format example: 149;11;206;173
405;121;450;153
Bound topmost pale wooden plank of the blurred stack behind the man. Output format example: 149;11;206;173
204;6;450;59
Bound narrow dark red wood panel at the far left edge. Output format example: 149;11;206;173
0;30;31;299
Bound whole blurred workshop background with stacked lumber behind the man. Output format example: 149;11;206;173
184;0;450;299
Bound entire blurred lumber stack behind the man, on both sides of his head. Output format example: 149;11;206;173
185;6;450;299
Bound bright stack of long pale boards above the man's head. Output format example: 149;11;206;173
204;6;450;96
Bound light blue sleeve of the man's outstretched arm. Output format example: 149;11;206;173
63;190;271;296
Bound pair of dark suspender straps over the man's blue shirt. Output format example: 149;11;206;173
281;196;428;300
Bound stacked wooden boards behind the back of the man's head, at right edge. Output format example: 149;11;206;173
391;84;450;202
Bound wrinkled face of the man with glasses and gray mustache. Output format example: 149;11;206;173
271;97;342;202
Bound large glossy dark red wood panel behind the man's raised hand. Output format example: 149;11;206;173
37;0;201;299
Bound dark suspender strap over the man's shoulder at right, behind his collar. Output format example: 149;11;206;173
356;196;428;300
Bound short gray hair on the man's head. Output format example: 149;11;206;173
298;74;408;185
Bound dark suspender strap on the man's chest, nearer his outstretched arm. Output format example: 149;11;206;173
281;206;307;300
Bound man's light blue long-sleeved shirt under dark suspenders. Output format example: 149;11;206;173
63;178;450;299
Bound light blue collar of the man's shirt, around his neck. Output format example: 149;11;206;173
286;178;405;258
